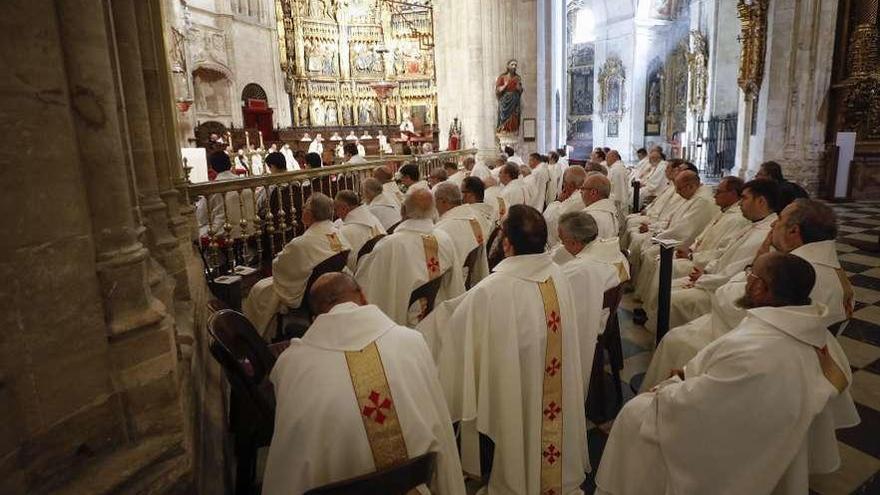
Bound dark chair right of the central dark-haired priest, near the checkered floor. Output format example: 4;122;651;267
587;285;623;420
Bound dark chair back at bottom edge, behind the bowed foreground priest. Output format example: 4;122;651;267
305;452;437;495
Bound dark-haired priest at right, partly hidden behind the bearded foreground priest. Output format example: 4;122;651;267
642;199;853;390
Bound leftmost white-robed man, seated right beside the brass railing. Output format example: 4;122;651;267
242;193;351;336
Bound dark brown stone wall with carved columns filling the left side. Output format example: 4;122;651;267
0;0;191;494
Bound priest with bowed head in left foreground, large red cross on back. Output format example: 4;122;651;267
263;273;465;495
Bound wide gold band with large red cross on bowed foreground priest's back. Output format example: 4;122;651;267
345;341;409;471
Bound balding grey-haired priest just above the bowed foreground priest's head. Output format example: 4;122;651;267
355;189;464;325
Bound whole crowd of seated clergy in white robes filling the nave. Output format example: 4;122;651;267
202;141;859;495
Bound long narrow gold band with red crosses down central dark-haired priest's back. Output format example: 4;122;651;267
538;278;562;494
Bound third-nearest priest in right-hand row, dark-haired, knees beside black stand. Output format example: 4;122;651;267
669;179;779;328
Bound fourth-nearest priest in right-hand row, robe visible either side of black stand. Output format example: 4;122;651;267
635;176;750;321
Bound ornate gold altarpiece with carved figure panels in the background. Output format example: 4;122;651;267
276;0;437;127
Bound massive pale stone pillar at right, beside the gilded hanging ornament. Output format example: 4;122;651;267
737;0;837;193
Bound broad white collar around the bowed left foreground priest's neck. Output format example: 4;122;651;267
302;302;396;352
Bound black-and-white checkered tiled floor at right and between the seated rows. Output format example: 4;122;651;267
585;202;880;495
